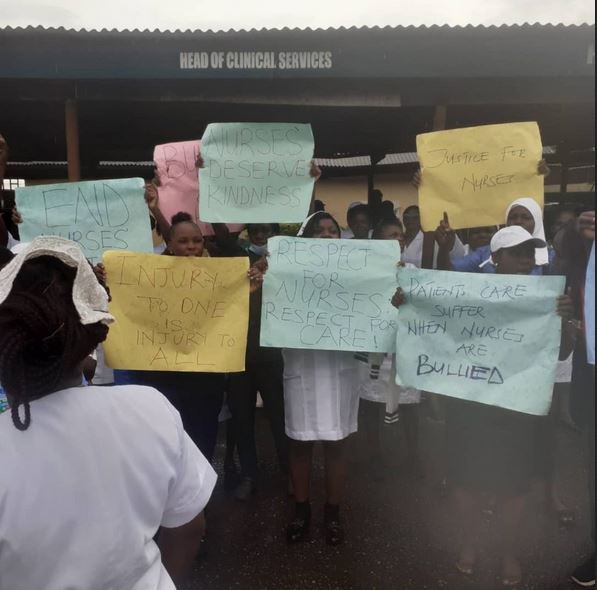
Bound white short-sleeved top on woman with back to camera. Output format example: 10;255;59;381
0;385;217;590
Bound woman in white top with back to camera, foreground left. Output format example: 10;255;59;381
0;237;216;590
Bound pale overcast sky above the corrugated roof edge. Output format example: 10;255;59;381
0;0;595;30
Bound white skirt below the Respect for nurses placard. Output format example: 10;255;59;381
283;349;359;441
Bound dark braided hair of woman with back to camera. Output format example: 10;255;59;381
0;261;108;430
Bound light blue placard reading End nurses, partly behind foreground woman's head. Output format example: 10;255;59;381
16;178;153;264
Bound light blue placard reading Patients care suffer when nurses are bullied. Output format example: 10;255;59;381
396;269;565;415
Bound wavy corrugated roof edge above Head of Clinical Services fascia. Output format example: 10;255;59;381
0;22;595;36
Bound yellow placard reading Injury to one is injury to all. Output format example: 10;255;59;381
104;251;249;373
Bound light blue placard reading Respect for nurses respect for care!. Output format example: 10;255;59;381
261;237;400;352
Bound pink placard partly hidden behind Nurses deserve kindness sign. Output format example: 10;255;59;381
153;139;244;236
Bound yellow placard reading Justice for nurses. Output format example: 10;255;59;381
417;123;544;231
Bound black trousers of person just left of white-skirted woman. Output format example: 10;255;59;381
227;361;288;478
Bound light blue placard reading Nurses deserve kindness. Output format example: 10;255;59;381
199;123;314;223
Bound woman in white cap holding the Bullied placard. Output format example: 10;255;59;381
393;225;573;587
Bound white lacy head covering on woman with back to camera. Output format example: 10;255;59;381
0;236;114;325
